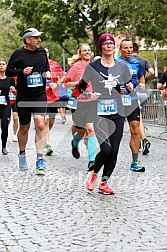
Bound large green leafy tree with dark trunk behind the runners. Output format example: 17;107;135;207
0;0;167;58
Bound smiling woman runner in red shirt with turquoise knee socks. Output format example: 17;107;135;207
64;43;97;170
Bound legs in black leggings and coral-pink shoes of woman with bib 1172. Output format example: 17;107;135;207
86;118;124;194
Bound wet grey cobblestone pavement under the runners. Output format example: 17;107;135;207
0;114;167;252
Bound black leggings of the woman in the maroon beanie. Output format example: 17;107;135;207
94;116;124;181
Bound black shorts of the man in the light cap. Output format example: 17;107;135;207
16;93;47;125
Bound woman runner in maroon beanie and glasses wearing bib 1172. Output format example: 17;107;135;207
78;33;133;194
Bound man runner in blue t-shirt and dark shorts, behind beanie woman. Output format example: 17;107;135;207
116;39;145;172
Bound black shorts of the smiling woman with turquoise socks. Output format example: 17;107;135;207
72;102;94;129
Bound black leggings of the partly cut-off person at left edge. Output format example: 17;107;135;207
0;104;11;148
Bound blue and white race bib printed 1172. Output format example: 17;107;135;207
97;99;117;115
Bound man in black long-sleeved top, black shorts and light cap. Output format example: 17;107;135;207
6;28;51;174
